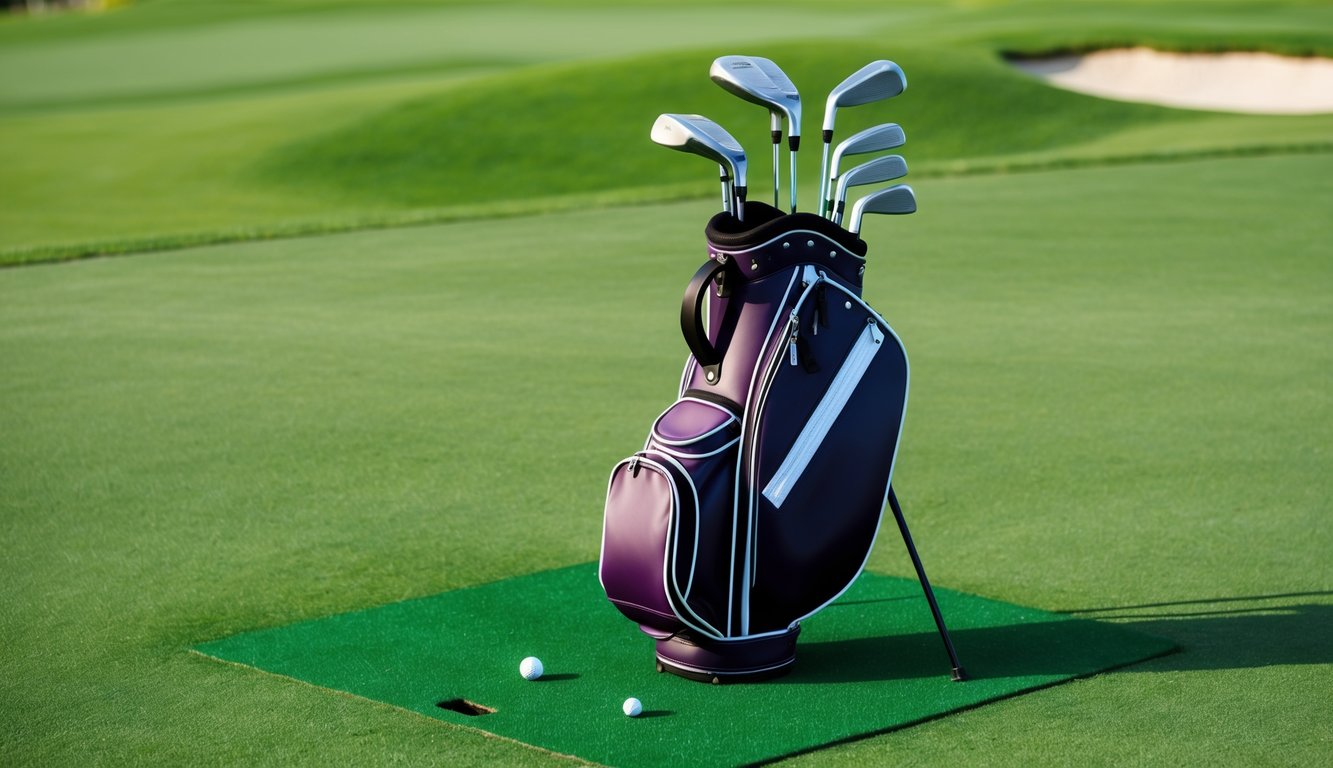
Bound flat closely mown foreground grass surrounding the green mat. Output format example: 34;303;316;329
0;155;1333;765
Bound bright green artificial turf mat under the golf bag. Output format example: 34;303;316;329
196;564;1174;765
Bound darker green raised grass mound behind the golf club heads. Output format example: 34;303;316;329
260;43;1192;205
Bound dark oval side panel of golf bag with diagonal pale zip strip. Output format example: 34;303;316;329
742;277;908;633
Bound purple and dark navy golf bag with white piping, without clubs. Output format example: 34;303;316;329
600;201;917;683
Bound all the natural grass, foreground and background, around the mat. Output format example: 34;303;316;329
0;0;1333;765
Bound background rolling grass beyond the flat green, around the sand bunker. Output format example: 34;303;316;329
0;1;1333;264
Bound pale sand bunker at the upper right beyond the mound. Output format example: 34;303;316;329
1012;48;1333;115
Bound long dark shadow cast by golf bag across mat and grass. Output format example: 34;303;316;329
785;592;1333;684
